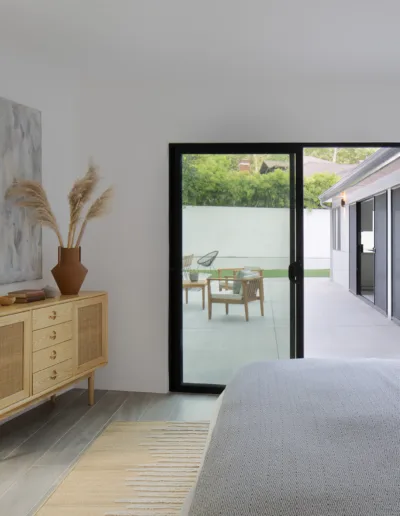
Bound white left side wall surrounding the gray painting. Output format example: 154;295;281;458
0;53;78;294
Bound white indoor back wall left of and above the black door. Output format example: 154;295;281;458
80;76;400;391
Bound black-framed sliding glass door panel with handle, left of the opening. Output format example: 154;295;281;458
170;144;303;392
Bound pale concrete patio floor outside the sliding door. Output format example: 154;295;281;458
183;278;400;384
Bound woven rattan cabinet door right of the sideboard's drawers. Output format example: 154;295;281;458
74;296;107;373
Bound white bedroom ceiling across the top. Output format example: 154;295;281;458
0;0;400;83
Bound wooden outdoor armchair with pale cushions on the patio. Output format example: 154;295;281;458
207;271;264;322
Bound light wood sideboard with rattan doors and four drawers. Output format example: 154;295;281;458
0;292;108;421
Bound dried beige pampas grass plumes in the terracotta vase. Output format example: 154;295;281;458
5;163;113;247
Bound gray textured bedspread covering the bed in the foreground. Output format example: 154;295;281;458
189;358;400;516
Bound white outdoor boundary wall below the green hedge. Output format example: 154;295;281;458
183;206;330;269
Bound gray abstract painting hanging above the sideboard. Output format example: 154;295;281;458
0;98;42;285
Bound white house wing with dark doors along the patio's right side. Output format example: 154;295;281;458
320;147;400;322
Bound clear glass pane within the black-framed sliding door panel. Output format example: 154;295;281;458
182;154;290;384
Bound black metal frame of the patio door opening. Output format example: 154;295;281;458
169;142;400;393
